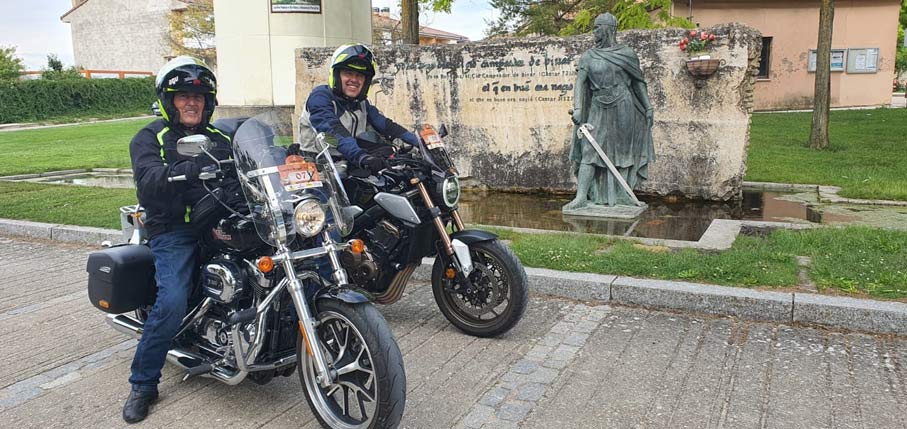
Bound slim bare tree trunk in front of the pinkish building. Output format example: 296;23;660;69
809;0;835;149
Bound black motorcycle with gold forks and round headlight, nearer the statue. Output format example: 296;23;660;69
341;125;528;337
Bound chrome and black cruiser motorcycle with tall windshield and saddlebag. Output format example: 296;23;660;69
87;112;406;429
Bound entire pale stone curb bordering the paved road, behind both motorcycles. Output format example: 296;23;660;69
0;219;907;335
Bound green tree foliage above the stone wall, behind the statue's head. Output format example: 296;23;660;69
486;0;693;36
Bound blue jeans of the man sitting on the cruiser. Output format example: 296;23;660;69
129;228;198;392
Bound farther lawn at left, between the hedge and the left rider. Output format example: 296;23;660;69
0;119;151;176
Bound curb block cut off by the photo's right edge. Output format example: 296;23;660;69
793;293;907;335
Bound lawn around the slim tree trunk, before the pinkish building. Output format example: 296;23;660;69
746;109;907;201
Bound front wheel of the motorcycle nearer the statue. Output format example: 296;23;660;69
431;240;529;337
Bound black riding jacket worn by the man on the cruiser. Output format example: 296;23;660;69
129;119;233;238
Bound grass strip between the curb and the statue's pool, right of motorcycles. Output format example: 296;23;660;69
495;227;907;299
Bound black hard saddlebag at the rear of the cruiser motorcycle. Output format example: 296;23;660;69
87;244;157;314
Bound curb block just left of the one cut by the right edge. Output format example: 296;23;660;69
611;277;793;322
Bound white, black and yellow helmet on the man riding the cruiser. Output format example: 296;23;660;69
154;55;217;127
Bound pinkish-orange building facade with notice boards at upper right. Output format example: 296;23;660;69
674;0;900;110
